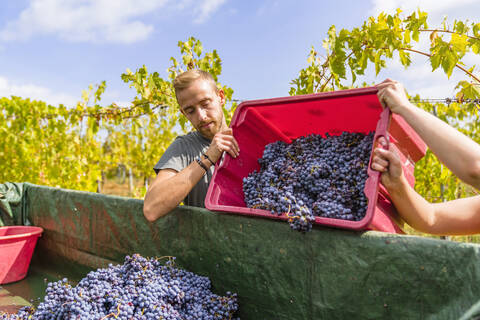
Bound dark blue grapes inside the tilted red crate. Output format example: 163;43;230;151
243;132;374;232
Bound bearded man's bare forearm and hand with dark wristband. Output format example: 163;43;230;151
143;129;240;221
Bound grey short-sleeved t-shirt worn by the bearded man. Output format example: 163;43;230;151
153;131;214;208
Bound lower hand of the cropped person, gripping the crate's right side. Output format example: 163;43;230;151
372;137;405;191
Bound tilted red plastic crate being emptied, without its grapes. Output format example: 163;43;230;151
205;87;426;233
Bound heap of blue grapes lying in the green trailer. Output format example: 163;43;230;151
0;254;238;320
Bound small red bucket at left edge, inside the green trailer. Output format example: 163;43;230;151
0;226;43;284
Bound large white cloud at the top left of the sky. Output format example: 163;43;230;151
0;0;226;44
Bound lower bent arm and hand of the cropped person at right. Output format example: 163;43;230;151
372;138;480;235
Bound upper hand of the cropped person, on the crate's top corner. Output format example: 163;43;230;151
376;79;411;114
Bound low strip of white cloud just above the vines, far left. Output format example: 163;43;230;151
0;76;79;106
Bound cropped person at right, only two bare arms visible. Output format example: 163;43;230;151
371;79;480;235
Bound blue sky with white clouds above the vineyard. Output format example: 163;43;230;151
0;0;480;104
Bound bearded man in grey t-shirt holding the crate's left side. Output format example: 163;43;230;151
143;70;240;221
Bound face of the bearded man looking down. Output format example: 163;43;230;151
177;79;225;140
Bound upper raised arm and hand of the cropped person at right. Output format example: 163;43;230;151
377;79;480;189
